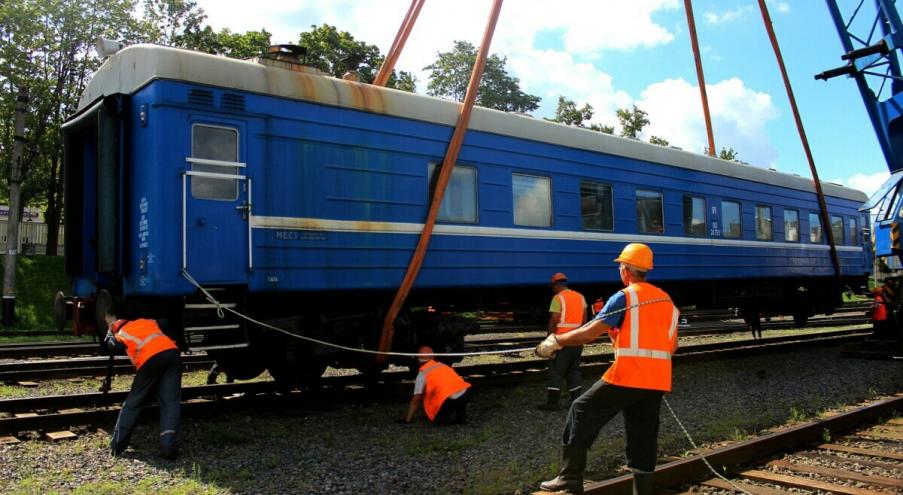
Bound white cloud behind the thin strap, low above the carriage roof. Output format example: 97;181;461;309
636;78;778;166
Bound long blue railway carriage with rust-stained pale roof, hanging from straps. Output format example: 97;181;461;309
64;45;871;380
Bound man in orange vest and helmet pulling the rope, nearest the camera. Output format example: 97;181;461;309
536;243;680;495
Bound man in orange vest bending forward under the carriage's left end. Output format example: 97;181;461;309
104;313;182;459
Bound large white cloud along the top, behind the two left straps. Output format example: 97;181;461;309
198;0;680;73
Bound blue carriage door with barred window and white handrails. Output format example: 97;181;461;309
182;124;251;284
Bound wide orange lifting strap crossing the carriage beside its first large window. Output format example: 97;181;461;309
375;0;502;364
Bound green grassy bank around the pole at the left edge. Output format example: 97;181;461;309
0;256;72;335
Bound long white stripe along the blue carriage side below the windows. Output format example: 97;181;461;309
251;215;862;253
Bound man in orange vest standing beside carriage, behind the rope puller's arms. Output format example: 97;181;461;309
538;272;586;411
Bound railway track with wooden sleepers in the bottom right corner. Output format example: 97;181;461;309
560;394;903;495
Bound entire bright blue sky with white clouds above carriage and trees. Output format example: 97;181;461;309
198;0;888;197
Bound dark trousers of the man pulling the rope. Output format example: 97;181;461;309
561;380;664;473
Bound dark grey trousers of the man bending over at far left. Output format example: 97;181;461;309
110;349;182;457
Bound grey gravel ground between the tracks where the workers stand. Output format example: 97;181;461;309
0;347;903;494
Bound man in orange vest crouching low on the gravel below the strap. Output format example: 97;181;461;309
399;346;470;426
